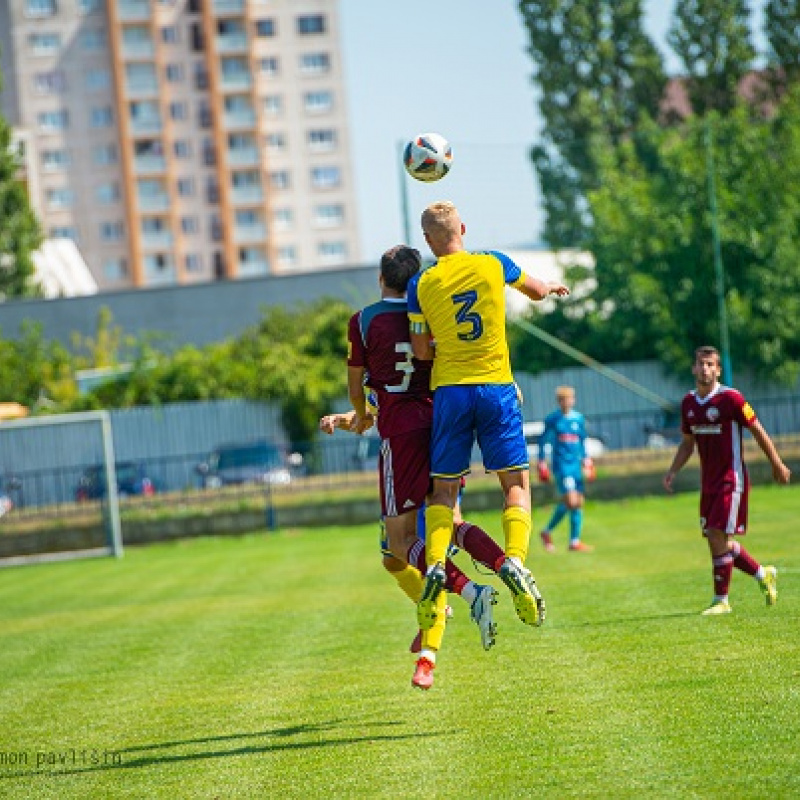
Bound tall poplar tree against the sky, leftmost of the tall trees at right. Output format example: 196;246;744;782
519;0;666;247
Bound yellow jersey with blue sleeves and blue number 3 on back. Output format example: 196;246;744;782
407;251;525;389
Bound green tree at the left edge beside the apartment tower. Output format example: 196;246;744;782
0;71;42;299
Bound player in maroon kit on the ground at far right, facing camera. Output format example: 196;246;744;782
664;347;791;615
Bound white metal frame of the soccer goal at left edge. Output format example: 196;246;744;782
0;411;124;567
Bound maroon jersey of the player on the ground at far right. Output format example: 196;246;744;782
681;385;756;494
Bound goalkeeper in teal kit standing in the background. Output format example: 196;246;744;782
538;386;595;552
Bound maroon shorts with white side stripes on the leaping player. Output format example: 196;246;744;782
378;428;431;517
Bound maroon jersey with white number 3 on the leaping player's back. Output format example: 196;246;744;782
347;298;433;439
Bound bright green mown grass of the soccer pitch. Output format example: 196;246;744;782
0;487;800;800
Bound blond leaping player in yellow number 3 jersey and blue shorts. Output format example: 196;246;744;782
408;201;569;629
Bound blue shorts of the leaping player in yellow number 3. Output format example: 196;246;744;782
431;383;528;478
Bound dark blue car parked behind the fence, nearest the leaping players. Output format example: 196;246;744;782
197;439;292;489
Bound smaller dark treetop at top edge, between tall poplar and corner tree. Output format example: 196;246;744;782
667;0;756;115
